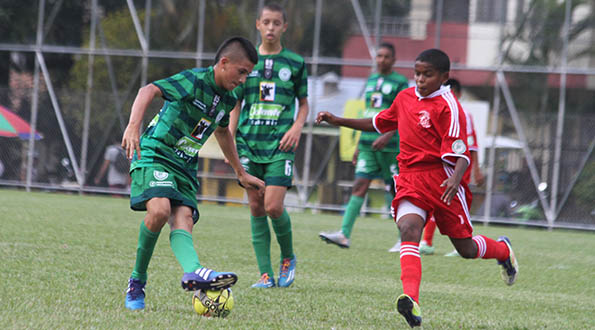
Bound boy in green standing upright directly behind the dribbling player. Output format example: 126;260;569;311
230;4;308;288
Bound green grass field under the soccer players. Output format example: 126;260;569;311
0;190;595;329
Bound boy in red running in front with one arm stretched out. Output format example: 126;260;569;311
316;49;518;327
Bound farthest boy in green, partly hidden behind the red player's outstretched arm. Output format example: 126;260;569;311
319;43;408;251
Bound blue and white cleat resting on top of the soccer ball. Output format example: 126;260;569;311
182;267;238;291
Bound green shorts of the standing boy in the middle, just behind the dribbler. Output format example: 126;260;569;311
240;157;293;188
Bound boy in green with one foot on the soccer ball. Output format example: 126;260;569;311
122;37;264;310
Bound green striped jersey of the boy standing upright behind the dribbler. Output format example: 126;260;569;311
234;48;308;163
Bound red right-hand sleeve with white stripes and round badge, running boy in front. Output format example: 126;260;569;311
437;94;471;166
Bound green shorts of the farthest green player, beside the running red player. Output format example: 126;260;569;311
355;150;399;184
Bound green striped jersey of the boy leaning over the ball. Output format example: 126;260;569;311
131;67;237;183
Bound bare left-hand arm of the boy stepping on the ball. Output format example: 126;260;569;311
122;84;162;159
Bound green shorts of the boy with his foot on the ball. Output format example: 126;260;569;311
130;164;199;223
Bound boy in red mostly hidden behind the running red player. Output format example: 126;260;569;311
419;78;484;257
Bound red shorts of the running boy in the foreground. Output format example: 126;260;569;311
392;165;473;238
